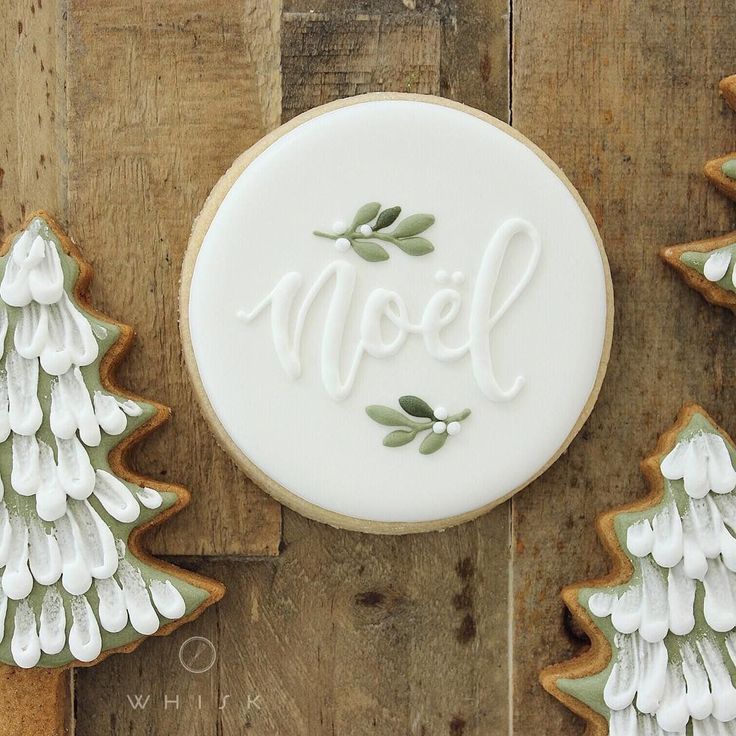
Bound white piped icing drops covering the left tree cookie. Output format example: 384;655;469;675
0;218;186;667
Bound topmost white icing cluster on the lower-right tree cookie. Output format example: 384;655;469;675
661;432;736;498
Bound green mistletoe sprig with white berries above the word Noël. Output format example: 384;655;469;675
314;202;434;263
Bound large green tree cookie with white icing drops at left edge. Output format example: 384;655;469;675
0;213;222;732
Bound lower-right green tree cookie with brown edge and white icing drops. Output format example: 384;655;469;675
542;405;736;736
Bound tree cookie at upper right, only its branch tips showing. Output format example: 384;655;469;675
661;75;736;311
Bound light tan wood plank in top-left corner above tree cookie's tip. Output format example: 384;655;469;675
0;0;66;233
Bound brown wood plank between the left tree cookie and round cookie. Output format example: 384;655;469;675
67;0;280;555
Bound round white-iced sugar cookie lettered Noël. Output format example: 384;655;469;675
181;94;613;533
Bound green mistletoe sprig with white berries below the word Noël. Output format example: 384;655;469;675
365;396;470;455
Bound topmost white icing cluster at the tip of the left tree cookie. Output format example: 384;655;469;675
0;229;64;307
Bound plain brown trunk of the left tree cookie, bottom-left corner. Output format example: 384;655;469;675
0;665;72;736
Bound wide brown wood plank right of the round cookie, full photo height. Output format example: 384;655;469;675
512;0;736;734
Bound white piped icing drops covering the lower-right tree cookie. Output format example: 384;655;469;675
588;431;736;736
